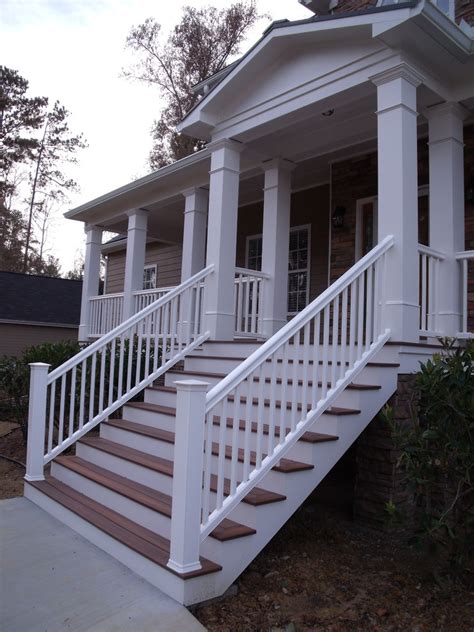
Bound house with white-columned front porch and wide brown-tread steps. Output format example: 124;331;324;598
25;0;474;604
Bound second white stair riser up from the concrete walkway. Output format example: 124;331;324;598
51;463;171;539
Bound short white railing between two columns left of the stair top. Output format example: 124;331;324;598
234;268;270;336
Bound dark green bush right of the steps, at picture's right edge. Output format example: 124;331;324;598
391;340;474;569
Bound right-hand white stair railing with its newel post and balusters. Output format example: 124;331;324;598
168;236;394;573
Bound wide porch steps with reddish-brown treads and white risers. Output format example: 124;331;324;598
25;341;399;605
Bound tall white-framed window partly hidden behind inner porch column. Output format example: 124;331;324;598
246;226;310;314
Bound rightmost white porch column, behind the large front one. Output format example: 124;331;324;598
424;103;468;336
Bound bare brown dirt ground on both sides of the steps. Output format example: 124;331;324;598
0;422;474;632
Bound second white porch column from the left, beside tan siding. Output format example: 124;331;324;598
122;209;148;321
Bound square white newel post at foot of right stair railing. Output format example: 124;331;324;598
168;380;209;573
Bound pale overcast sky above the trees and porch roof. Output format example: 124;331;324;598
0;0;311;271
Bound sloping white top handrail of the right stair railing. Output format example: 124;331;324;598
206;235;394;412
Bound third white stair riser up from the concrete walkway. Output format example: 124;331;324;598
76;443;173;495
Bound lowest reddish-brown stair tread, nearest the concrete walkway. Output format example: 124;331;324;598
29;477;222;579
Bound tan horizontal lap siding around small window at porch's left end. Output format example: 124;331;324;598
105;244;182;294
